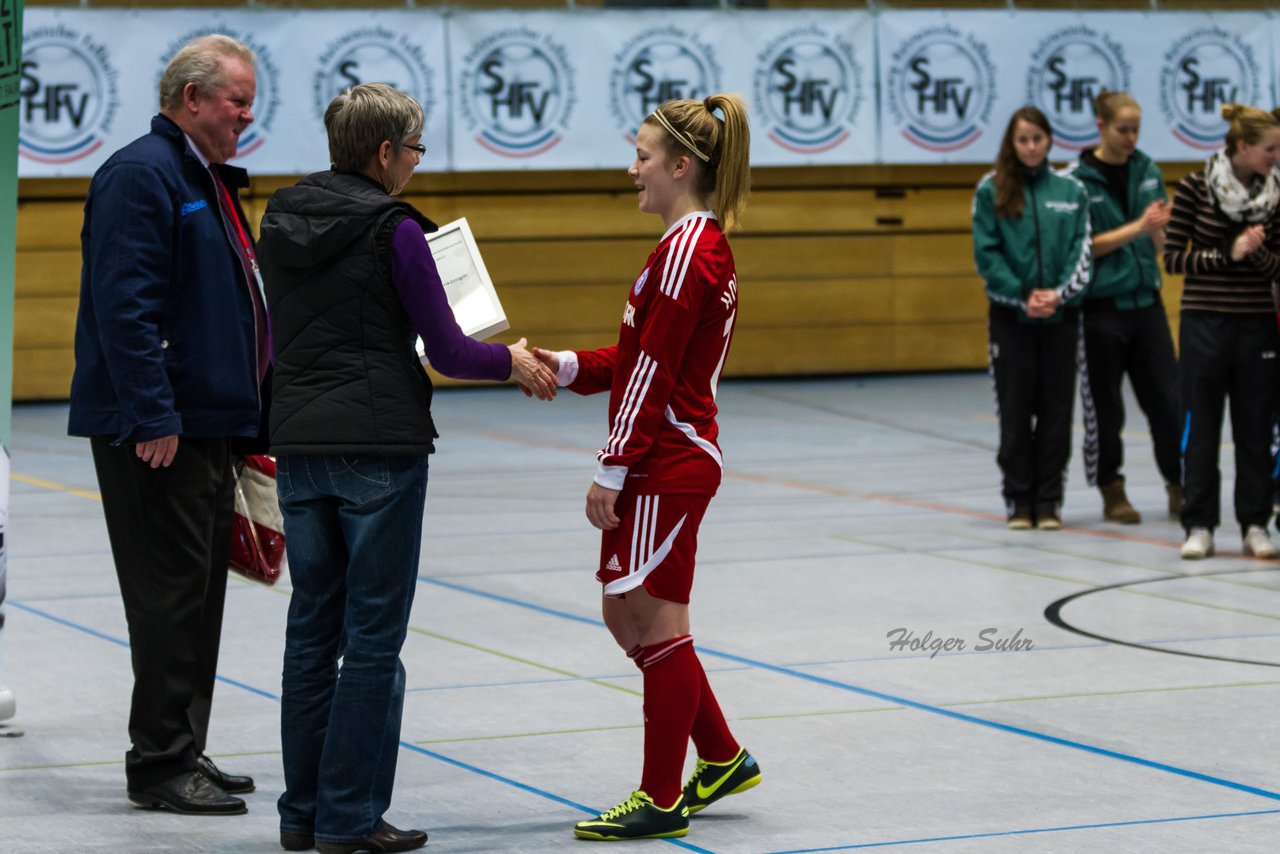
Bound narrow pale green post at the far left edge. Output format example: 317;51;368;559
0;0;22;721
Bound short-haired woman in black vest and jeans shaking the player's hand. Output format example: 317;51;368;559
259;83;556;854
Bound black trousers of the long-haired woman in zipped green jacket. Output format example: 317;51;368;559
987;305;1080;511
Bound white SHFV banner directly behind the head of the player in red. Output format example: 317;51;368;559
449;12;876;170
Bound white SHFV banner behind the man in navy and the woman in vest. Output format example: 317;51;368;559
19;8;448;177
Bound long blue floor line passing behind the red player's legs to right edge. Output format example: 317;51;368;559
419;575;1280;800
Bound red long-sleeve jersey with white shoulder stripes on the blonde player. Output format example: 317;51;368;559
568;211;737;495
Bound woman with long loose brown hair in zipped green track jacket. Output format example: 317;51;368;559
973;106;1092;530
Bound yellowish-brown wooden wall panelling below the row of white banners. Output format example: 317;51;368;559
14;164;1194;399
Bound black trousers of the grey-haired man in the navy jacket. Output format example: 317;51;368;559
91;438;239;790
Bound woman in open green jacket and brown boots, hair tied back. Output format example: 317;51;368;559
1068;91;1183;525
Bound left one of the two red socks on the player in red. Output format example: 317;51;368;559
640;635;701;809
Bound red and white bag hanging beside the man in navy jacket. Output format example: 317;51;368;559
229;455;284;584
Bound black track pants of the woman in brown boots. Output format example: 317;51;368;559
1080;300;1181;487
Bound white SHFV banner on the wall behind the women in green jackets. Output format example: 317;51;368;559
879;12;1277;163
